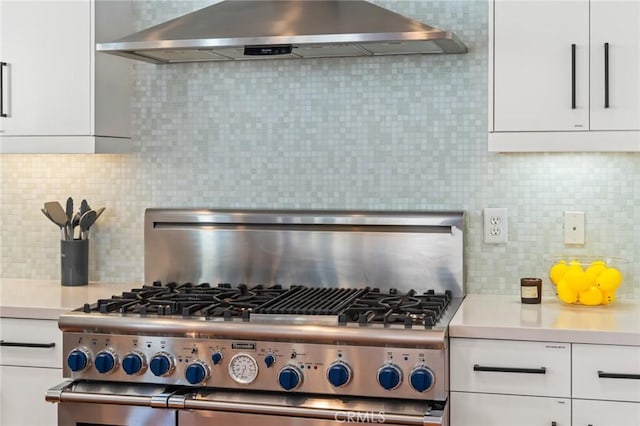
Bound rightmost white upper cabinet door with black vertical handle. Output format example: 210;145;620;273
591;0;640;130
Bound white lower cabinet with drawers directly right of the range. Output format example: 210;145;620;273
449;339;571;426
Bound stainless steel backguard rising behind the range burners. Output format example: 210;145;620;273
144;209;465;297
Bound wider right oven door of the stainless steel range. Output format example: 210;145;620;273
169;389;448;426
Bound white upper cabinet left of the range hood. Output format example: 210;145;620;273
0;0;132;153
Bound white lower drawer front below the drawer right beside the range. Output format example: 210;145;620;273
449;392;571;426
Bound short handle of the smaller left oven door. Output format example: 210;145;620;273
45;380;172;408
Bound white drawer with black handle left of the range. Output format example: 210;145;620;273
0;318;62;368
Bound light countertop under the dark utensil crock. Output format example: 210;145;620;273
0;278;136;320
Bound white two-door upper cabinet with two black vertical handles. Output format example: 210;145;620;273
489;0;640;151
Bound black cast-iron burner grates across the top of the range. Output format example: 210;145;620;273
83;282;452;328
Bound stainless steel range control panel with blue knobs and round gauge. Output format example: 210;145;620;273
63;333;448;400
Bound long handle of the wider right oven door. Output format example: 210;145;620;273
169;395;443;426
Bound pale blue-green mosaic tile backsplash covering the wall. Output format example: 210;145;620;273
0;0;640;298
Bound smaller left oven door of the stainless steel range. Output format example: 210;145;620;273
46;381;177;426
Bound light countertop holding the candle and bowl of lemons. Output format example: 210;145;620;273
449;294;640;346
